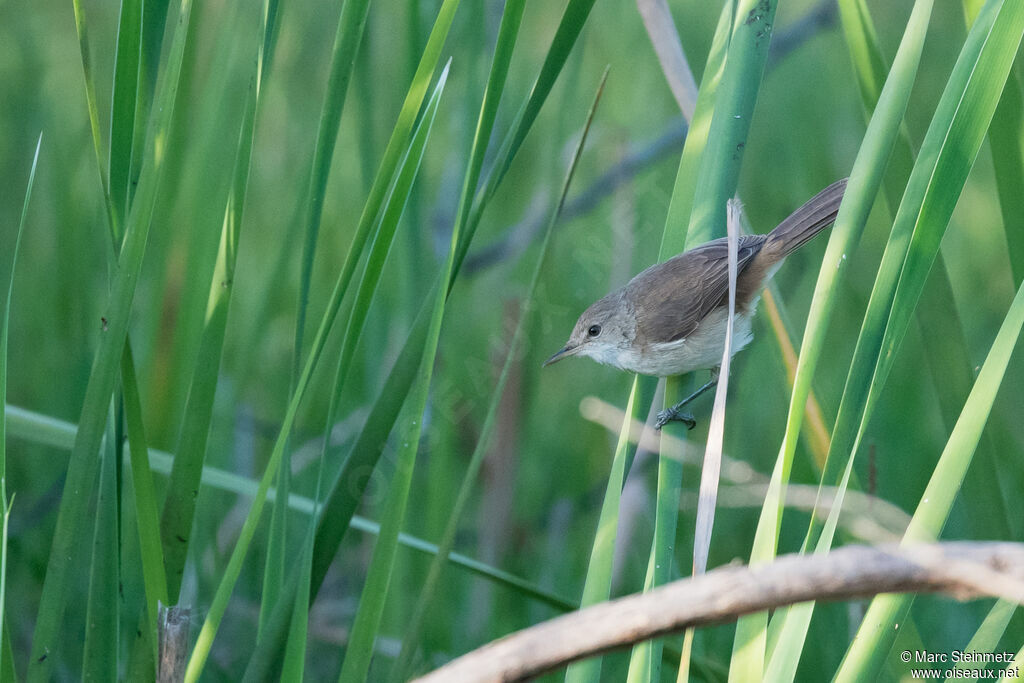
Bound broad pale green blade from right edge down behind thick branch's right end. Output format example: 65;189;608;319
836;270;1024;681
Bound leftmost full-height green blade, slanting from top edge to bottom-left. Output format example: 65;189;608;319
29;0;191;681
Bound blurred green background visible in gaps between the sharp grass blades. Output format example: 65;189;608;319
0;0;1024;680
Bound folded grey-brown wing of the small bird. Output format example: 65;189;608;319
627;234;765;344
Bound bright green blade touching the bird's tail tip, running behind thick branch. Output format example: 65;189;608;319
737;0;933;680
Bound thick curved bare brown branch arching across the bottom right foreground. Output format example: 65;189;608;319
418;542;1024;683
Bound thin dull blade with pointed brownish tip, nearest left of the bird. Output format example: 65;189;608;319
391;58;608;681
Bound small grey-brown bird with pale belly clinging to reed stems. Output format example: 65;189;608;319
544;178;846;429
